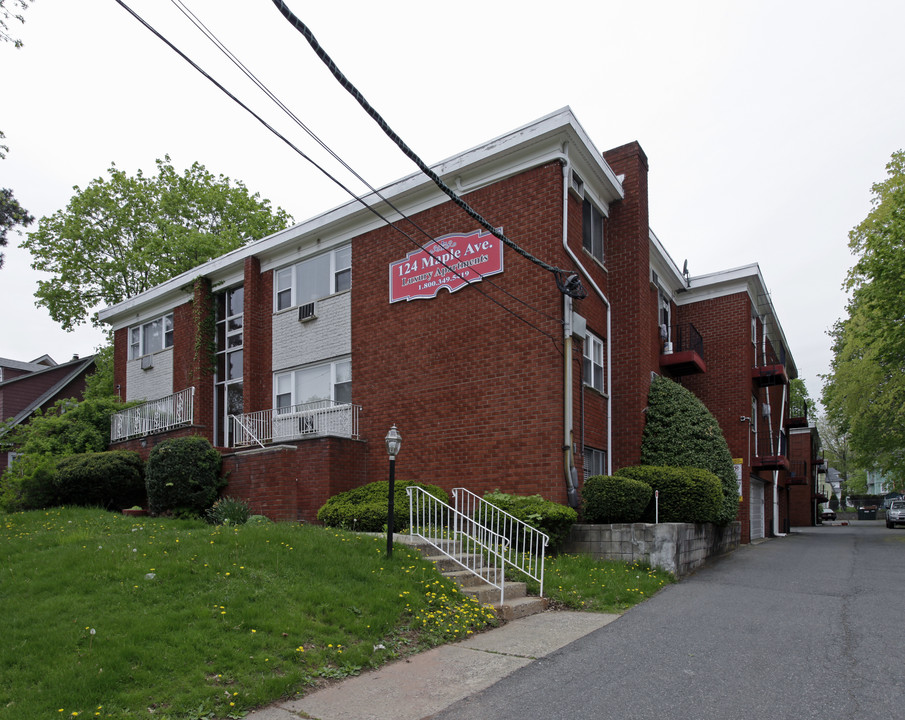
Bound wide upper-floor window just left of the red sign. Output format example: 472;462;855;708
273;245;352;310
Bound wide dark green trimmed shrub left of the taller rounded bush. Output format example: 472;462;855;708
56;450;146;510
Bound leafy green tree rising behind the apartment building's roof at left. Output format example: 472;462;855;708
22;155;292;330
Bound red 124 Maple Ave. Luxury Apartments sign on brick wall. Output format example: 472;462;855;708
390;230;503;303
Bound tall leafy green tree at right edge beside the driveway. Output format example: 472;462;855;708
822;150;905;487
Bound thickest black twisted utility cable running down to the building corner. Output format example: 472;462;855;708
273;0;568;275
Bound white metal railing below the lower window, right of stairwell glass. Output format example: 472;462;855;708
229;400;361;447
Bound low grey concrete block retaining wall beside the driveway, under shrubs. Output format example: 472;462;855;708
563;522;741;577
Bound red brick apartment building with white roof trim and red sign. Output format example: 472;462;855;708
100;108;797;542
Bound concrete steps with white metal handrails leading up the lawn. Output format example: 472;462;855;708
404;486;548;620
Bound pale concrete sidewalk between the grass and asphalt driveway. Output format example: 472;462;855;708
248;611;619;720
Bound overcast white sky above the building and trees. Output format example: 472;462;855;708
0;0;905;399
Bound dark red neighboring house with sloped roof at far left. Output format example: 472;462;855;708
0;355;94;472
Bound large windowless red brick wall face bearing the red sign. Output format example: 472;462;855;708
352;163;580;502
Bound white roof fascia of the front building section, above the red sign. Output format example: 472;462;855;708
98;107;624;328
